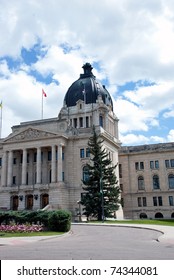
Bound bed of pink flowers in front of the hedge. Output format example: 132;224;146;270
0;224;43;233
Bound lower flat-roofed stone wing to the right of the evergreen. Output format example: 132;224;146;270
119;143;174;219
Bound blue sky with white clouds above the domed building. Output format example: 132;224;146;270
0;0;174;148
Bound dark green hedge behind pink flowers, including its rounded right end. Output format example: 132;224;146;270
0;210;71;232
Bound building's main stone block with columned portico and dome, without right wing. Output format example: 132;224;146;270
0;64;121;221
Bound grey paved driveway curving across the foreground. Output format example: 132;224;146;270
0;224;174;260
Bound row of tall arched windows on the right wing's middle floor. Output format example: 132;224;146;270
138;174;174;190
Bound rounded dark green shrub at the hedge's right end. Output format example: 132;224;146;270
48;210;71;232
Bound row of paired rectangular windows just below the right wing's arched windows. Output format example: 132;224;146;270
137;195;174;207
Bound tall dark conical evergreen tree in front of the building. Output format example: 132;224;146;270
81;127;120;221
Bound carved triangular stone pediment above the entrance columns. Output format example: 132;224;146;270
4;127;57;143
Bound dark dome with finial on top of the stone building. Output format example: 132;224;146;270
64;63;113;110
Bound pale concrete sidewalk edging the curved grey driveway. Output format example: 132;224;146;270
0;223;174;246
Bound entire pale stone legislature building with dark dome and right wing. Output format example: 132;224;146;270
0;63;174;219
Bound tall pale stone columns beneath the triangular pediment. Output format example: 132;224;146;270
1;144;62;187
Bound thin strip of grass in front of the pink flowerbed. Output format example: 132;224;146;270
0;231;64;238
